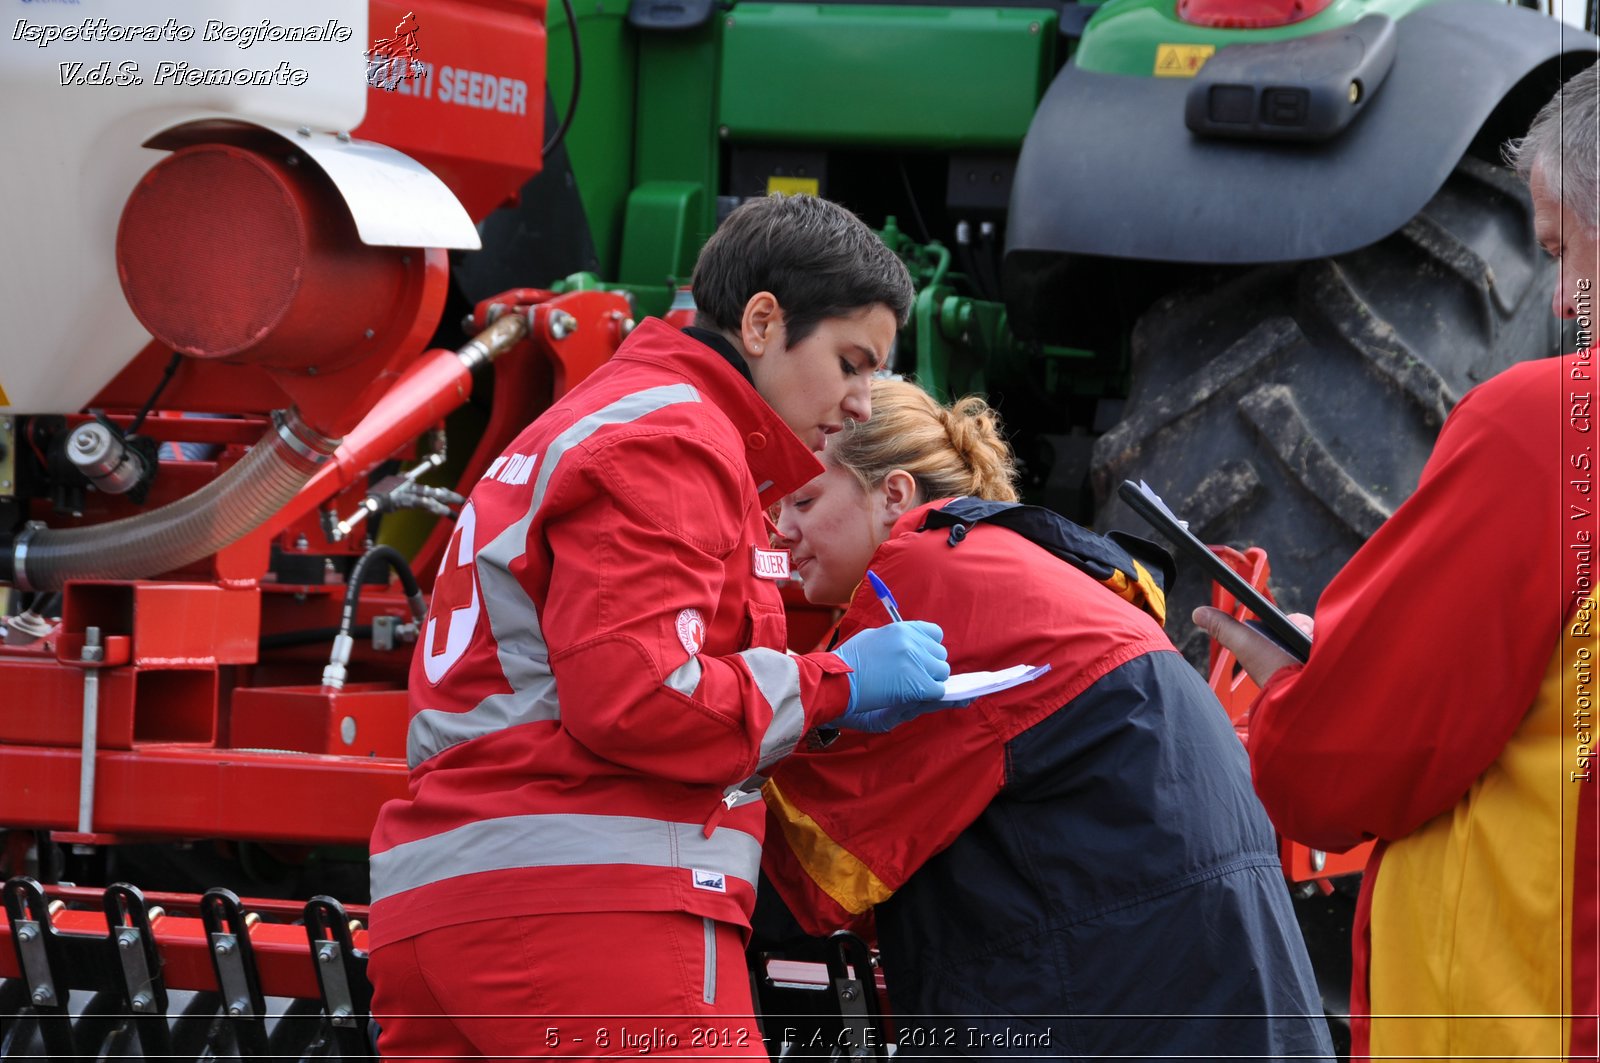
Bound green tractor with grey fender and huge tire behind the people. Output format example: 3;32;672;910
444;0;1600;1044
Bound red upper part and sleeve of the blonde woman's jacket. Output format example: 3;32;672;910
766;503;1177;935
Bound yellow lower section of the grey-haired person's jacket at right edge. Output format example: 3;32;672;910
1370;597;1597;1060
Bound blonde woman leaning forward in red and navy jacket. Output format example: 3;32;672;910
763;381;1333;1058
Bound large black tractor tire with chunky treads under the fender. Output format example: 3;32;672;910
1091;157;1562;664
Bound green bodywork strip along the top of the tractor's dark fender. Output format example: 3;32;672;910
1072;0;1452;77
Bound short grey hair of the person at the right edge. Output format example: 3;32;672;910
1506;64;1600;232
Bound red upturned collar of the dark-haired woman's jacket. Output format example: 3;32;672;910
614;317;822;507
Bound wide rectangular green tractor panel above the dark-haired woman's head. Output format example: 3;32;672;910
717;3;1056;149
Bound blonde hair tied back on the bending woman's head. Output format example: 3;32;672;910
827;379;1018;503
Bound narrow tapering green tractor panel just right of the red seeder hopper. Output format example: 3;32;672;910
546;0;638;277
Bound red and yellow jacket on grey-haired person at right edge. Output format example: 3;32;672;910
1250;352;1600;1058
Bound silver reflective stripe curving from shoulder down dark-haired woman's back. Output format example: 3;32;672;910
406;384;701;768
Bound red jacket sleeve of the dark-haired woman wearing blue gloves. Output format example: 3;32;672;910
541;431;850;786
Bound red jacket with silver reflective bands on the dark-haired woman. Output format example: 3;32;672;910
371;320;850;946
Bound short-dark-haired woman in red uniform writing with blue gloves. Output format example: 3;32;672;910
370;197;949;1058
